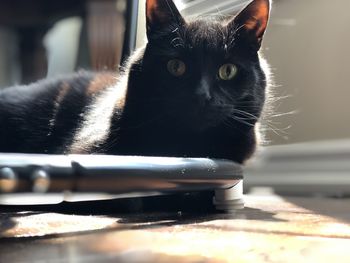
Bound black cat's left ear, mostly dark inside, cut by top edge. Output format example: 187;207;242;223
146;0;185;39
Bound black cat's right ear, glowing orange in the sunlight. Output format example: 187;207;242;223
229;0;270;51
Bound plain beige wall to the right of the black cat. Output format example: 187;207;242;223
264;0;350;143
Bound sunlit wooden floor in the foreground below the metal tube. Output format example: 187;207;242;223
0;195;350;263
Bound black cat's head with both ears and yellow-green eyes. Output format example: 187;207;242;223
138;0;270;130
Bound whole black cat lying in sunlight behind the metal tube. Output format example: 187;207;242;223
0;0;270;163
